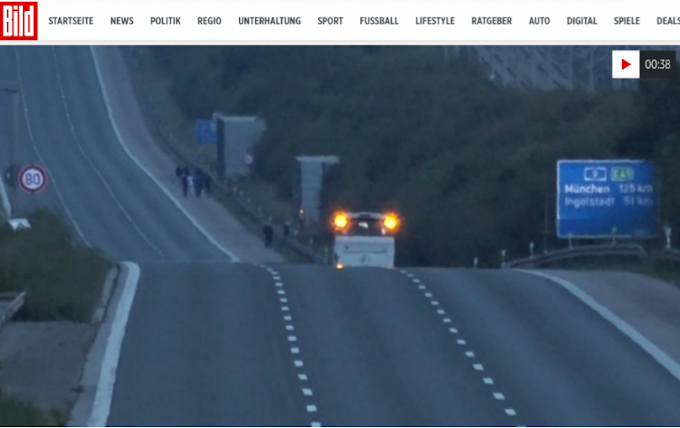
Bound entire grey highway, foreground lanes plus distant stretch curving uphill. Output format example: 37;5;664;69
0;47;680;426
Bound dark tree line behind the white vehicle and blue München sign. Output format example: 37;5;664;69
152;46;680;266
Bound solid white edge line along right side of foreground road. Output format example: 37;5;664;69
515;269;680;380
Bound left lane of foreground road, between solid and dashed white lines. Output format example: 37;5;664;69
108;263;309;426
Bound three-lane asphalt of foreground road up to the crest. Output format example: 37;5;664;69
109;263;680;426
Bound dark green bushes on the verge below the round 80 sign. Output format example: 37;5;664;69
0;209;114;322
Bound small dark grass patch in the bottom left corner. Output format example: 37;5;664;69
0;391;68;427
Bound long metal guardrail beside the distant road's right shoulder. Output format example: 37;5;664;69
123;47;328;264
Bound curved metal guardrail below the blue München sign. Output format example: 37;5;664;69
501;244;648;268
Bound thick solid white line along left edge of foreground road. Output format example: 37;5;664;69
87;262;141;427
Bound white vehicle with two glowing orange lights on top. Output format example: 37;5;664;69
332;212;400;269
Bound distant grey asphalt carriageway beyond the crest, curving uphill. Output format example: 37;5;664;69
0;46;225;262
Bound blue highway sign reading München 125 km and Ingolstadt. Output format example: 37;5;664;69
557;160;658;238
